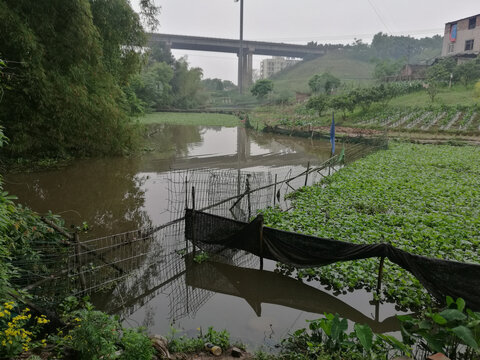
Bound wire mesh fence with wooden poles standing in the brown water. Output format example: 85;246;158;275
24;138;385;319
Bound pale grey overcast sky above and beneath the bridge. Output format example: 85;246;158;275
132;0;480;83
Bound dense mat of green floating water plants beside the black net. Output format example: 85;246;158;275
265;144;480;308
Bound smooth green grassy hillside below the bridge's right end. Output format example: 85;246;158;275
272;52;374;93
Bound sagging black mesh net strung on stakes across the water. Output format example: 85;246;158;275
185;209;480;311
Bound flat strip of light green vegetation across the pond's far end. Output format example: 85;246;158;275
139;112;241;127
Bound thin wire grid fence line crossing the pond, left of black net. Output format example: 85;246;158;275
18;142;385;313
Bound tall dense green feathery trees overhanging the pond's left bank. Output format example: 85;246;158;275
0;0;159;157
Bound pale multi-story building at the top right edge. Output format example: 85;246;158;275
442;14;480;58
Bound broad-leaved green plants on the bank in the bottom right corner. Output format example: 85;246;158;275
276;297;480;360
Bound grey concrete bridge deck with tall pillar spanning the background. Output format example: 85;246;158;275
148;33;325;88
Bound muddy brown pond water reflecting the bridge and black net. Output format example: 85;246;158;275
4;125;398;347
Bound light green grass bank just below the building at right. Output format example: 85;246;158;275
390;85;479;106
